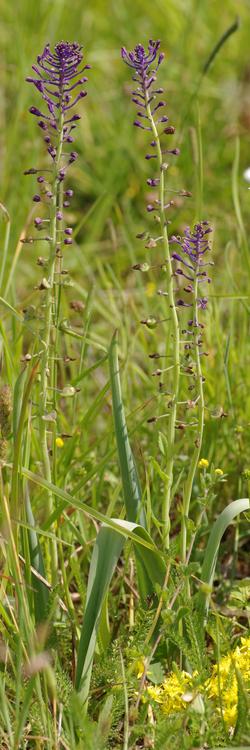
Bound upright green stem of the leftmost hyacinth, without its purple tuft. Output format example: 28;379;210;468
40;111;64;583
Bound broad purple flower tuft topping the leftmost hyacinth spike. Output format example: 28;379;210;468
24;41;90;244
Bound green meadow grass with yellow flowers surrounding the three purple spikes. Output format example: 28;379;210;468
0;0;250;750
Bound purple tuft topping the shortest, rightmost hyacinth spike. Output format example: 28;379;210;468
170;221;213;318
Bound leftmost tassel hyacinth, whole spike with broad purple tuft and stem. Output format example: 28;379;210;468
24;41;90;578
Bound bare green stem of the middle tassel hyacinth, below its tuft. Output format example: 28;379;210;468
145;97;180;549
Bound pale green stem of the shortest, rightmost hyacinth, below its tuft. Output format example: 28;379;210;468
181;276;205;563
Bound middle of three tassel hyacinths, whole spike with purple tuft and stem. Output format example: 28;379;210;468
121;40;181;548
